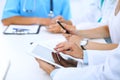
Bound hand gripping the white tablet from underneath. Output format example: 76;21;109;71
35;58;55;75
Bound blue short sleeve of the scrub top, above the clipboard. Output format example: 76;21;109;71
2;0;20;19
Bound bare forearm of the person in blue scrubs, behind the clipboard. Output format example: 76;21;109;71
2;16;50;26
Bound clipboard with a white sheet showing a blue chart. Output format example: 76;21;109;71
3;25;41;35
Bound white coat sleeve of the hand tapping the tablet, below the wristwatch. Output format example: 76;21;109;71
87;43;119;65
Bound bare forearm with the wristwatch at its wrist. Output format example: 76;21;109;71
85;41;118;50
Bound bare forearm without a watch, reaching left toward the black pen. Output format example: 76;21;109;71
77;26;110;39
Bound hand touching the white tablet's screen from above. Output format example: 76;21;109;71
54;41;83;59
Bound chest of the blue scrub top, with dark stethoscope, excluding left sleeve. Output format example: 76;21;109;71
19;0;63;18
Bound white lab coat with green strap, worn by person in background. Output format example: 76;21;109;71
71;0;117;25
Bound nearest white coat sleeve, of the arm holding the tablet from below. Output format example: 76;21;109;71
53;45;120;80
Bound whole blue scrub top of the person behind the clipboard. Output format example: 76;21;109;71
2;0;71;20
